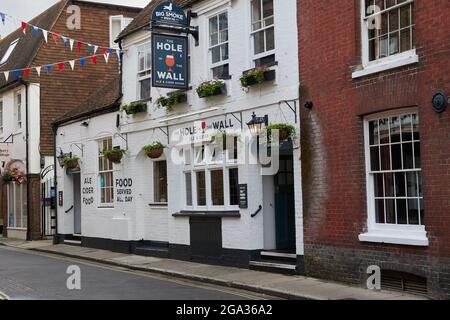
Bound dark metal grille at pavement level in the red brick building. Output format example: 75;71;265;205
381;270;428;296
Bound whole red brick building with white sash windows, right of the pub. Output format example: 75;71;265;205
298;0;450;298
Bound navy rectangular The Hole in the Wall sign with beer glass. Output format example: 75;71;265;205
152;33;189;89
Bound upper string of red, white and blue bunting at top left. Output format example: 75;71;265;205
0;12;120;60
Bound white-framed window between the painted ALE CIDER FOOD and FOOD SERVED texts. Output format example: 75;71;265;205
98;138;114;206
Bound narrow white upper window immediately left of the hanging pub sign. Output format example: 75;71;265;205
138;44;152;100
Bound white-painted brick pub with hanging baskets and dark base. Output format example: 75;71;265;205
55;0;303;273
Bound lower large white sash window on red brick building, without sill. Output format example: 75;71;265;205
365;112;424;231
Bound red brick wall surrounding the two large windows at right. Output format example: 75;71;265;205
298;0;450;284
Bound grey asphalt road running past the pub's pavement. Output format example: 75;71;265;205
0;247;271;300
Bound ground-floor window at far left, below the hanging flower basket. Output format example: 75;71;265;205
7;182;27;229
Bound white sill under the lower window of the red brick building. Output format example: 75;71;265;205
358;230;429;247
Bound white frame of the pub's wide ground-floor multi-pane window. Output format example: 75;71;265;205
183;145;239;211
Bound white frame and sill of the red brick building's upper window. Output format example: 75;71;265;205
352;0;419;79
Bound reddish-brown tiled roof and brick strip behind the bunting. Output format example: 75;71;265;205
31;2;138;155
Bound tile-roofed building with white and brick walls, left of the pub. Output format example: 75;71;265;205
0;0;140;240
